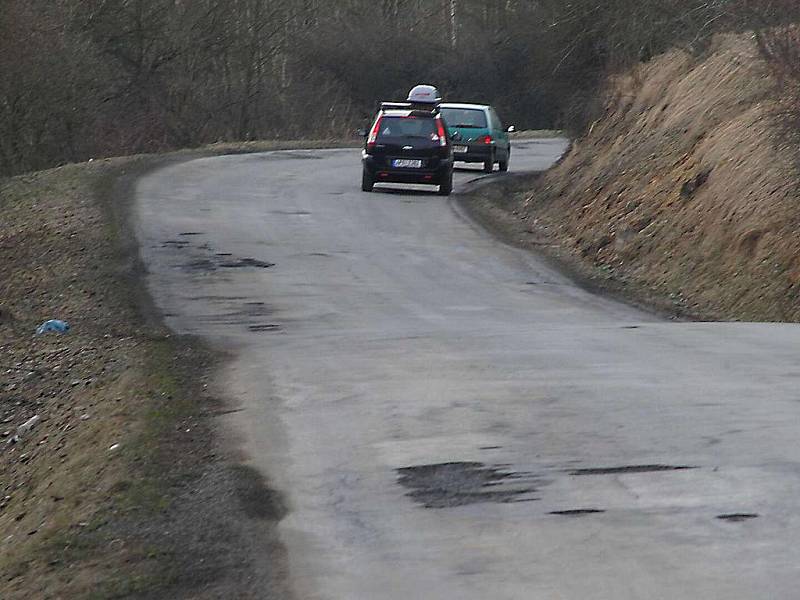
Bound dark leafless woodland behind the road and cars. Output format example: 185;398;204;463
0;0;800;175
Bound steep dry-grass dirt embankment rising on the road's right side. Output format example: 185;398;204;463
468;36;800;321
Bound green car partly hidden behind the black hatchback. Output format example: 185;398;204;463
440;103;514;173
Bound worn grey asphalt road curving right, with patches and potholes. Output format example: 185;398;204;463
136;140;800;600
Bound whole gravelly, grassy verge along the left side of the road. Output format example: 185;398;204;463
0;142;354;599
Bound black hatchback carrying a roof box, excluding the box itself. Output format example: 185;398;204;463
361;102;453;196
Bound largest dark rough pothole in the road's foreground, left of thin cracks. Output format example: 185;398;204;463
397;462;538;508
